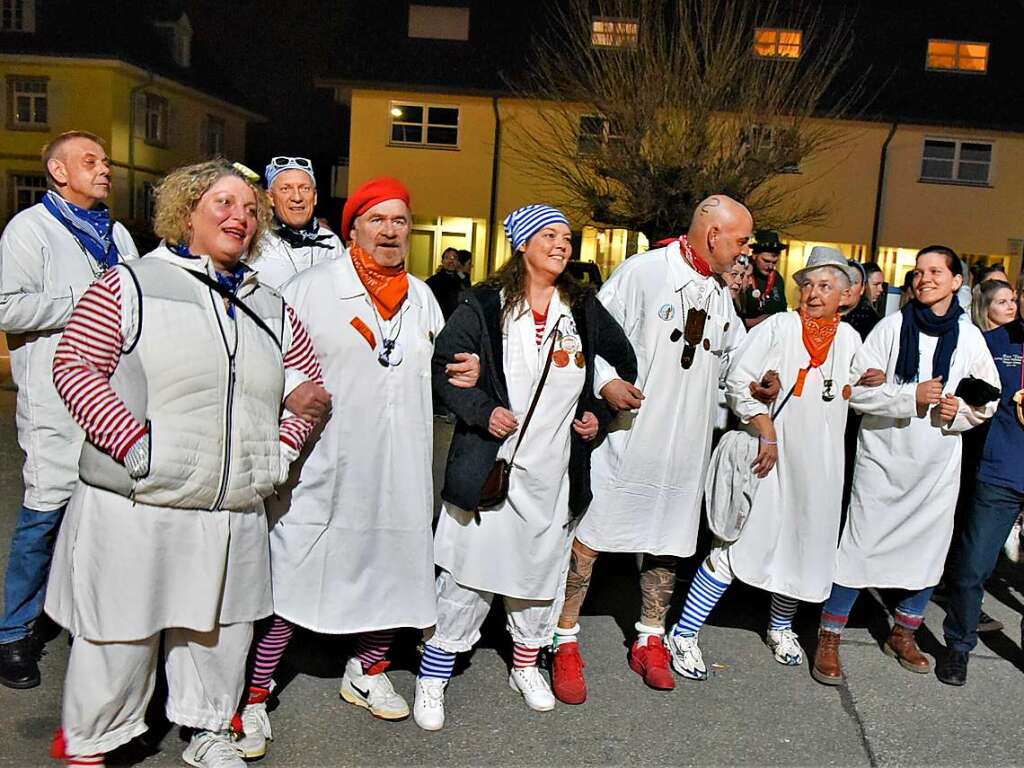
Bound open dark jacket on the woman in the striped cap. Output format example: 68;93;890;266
432;286;637;517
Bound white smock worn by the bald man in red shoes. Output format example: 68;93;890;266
577;243;745;557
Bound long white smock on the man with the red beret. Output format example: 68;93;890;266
267;255;444;634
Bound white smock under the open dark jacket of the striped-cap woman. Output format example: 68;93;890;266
434;291;587;600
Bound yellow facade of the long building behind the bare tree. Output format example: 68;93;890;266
337;83;1024;290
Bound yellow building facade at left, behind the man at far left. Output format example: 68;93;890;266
0;53;263;232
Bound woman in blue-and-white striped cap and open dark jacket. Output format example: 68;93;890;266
413;205;636;730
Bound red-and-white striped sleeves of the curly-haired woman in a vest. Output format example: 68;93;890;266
53;269;324;462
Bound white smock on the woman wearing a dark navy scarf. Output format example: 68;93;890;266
836;312;999;590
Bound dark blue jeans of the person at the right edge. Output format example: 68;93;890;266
942;480;1024;653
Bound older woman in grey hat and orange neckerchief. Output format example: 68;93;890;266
669;246;878;680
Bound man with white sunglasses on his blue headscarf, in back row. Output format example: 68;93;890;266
250;157;345;289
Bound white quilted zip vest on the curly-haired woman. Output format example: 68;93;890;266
79;249;286;510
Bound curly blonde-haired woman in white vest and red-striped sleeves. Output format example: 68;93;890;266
46;161;321;768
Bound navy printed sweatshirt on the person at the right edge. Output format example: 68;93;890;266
978;321;1024;494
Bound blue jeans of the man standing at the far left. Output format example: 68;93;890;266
0;507;65;645
